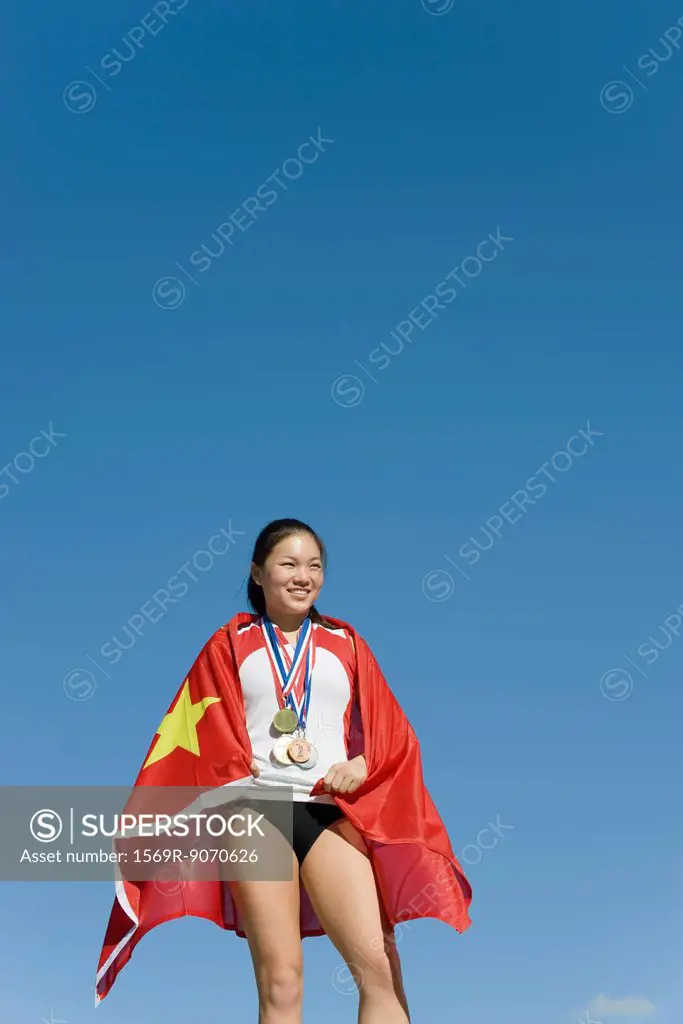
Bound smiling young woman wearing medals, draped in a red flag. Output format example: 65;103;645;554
97;519;471;1024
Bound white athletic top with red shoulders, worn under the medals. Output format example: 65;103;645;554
236;620;355;804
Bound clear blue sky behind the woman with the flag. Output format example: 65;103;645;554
0;0;683;1024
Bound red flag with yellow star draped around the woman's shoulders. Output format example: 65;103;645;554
95;612;472;1004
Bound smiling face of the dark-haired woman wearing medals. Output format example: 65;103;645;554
252;534;324;618
